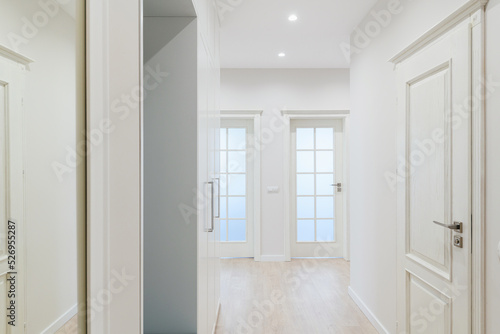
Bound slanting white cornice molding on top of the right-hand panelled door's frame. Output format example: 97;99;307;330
389;0;489;64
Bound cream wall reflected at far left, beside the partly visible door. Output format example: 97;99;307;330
0;0;85;334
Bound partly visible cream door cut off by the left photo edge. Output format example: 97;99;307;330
0;56;25;334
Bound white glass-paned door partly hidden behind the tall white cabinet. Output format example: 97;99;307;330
220;119;254;257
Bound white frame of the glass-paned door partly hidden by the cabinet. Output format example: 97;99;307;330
220;110;262;261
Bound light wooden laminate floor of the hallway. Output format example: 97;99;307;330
216;259;377;334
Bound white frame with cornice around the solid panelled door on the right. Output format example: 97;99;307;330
390;0;488;334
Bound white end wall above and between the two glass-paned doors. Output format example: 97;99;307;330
221;69;350;260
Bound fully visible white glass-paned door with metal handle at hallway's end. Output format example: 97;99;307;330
290;119;344;257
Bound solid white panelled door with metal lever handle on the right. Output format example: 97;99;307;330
396;18;471;334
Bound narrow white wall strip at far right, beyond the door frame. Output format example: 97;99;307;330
486;0;500;333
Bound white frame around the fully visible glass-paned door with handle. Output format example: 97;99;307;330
281;110;350;261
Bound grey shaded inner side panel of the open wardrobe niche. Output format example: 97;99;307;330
144;17;198;334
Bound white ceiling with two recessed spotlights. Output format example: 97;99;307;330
219;0;377;68
